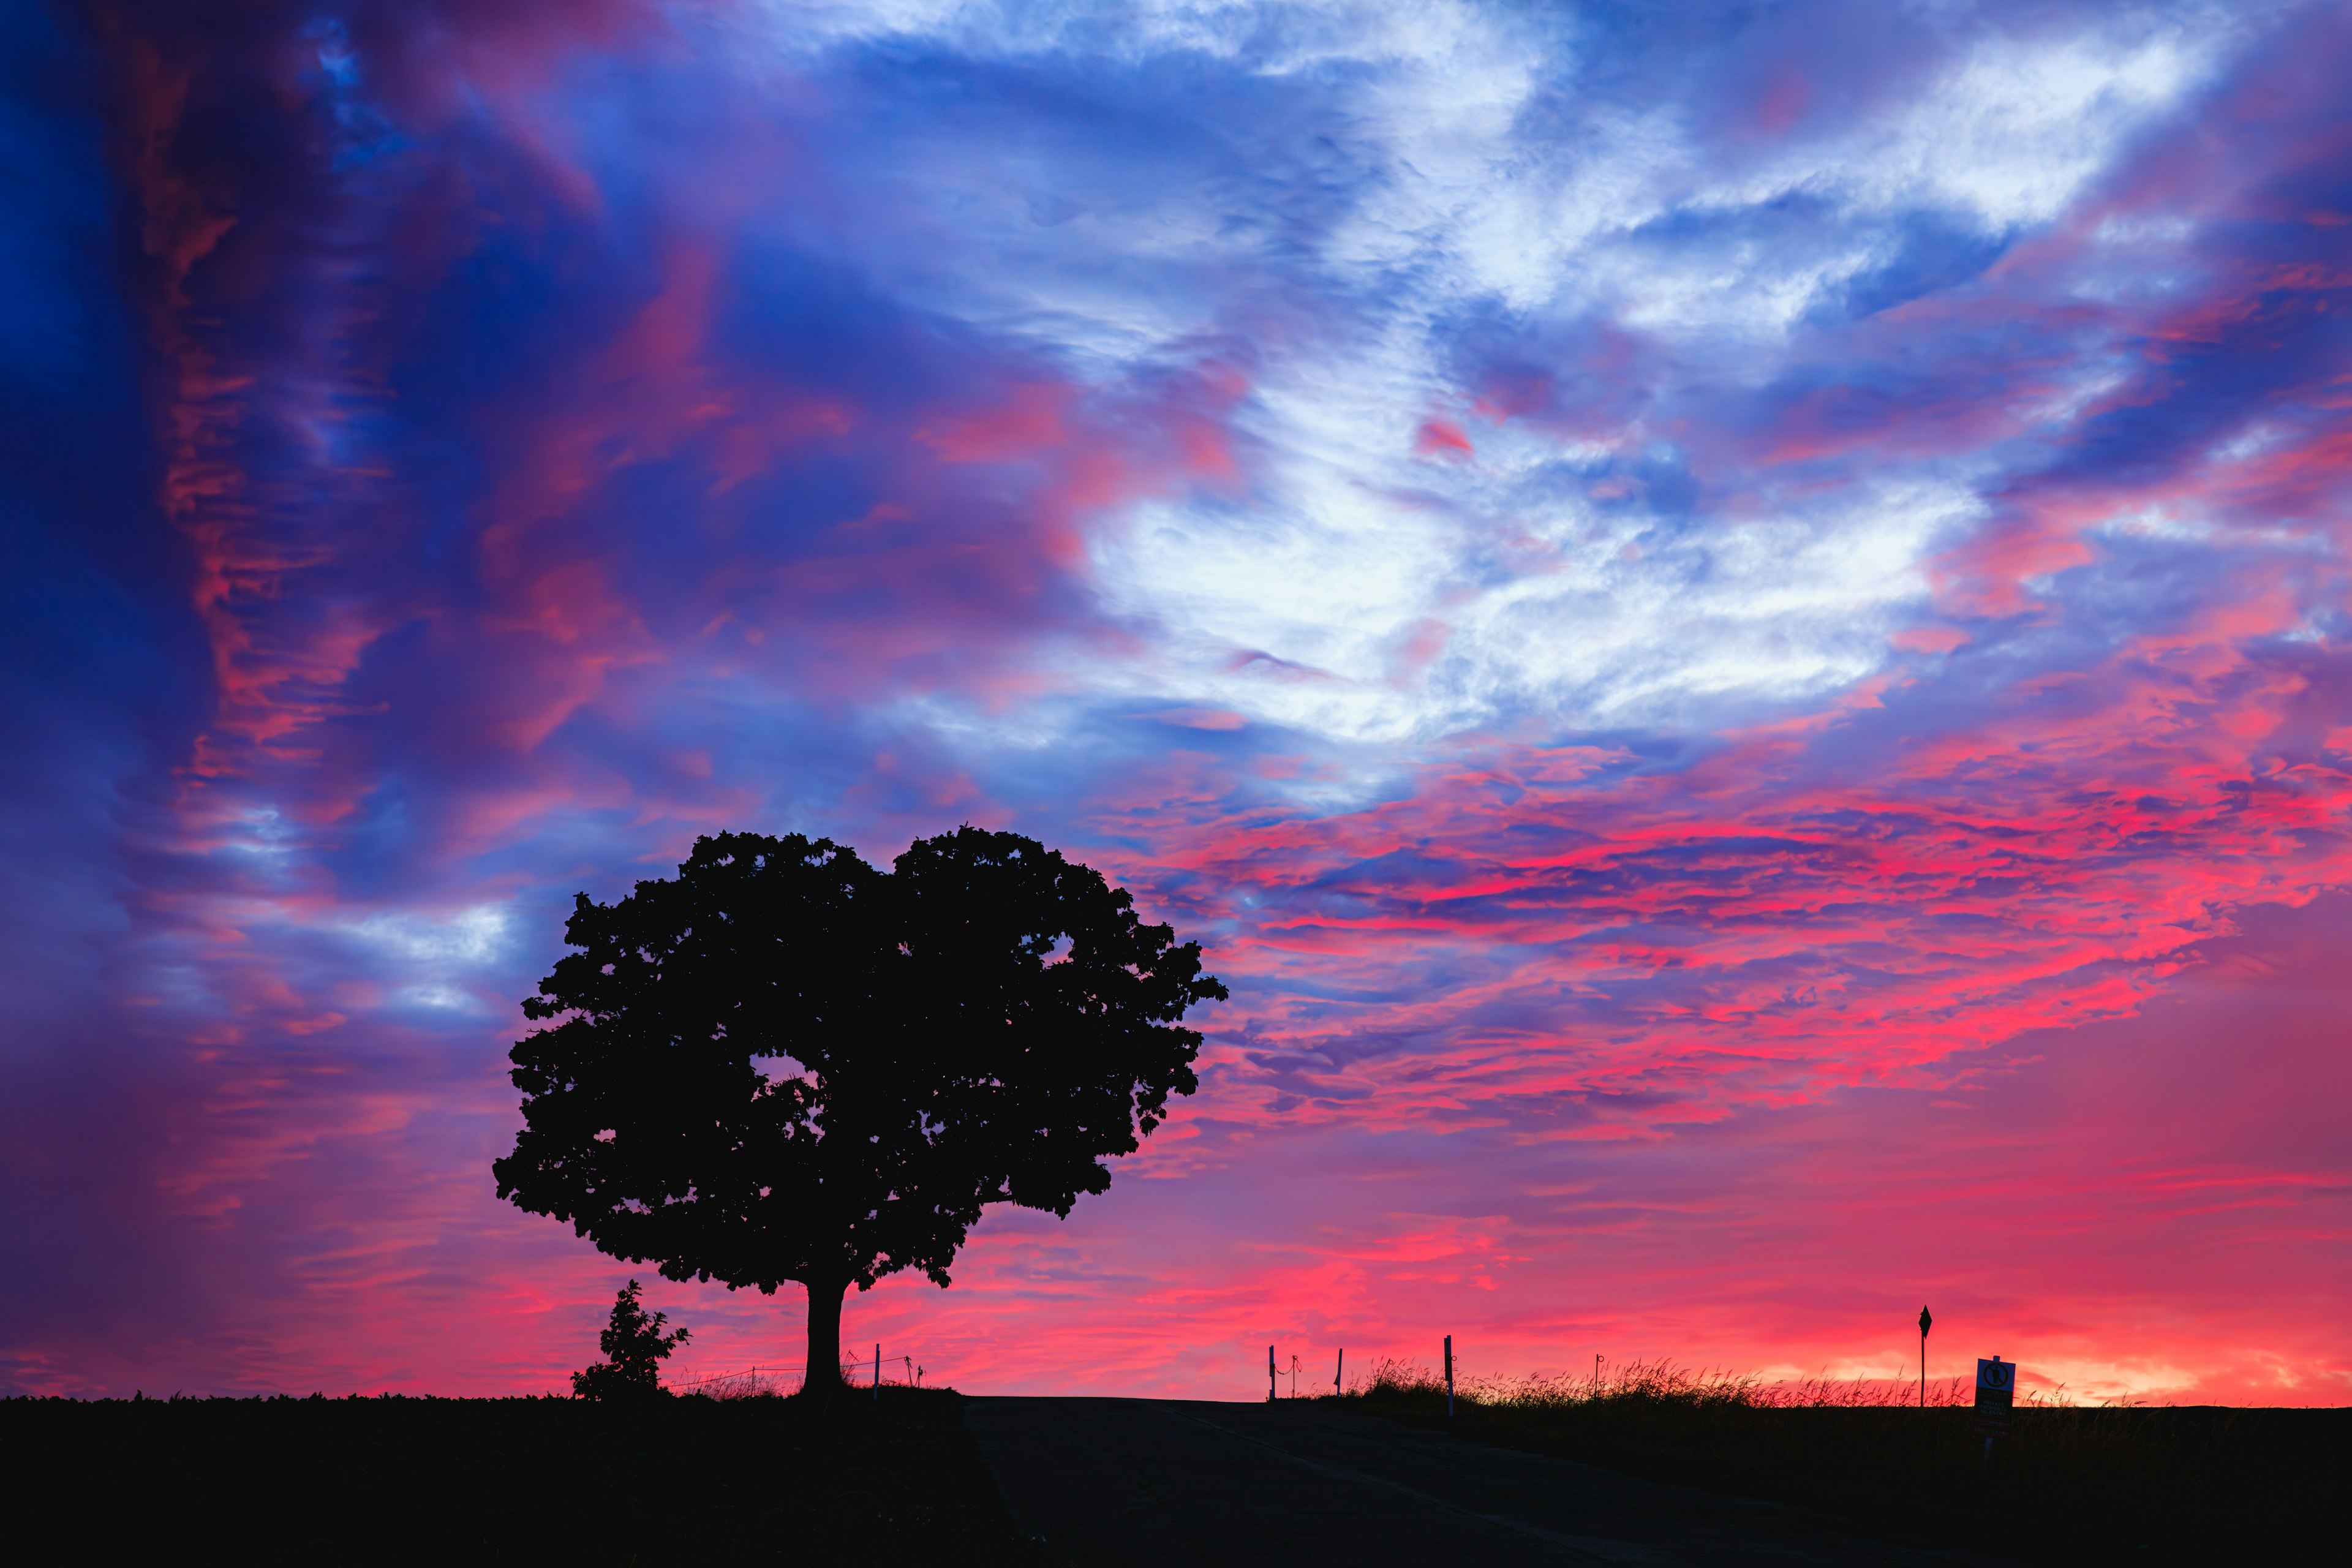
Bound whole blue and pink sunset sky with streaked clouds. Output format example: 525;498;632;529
0;0;2352;1403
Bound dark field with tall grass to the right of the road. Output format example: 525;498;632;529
1324;1363;2352;1563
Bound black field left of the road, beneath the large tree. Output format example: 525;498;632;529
0;1387;1037;1566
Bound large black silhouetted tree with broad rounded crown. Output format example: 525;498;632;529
492;827;1226;1392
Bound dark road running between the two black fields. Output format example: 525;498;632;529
964;1399;1990;1568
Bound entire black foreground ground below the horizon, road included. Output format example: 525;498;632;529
0;1389;2352;1568
